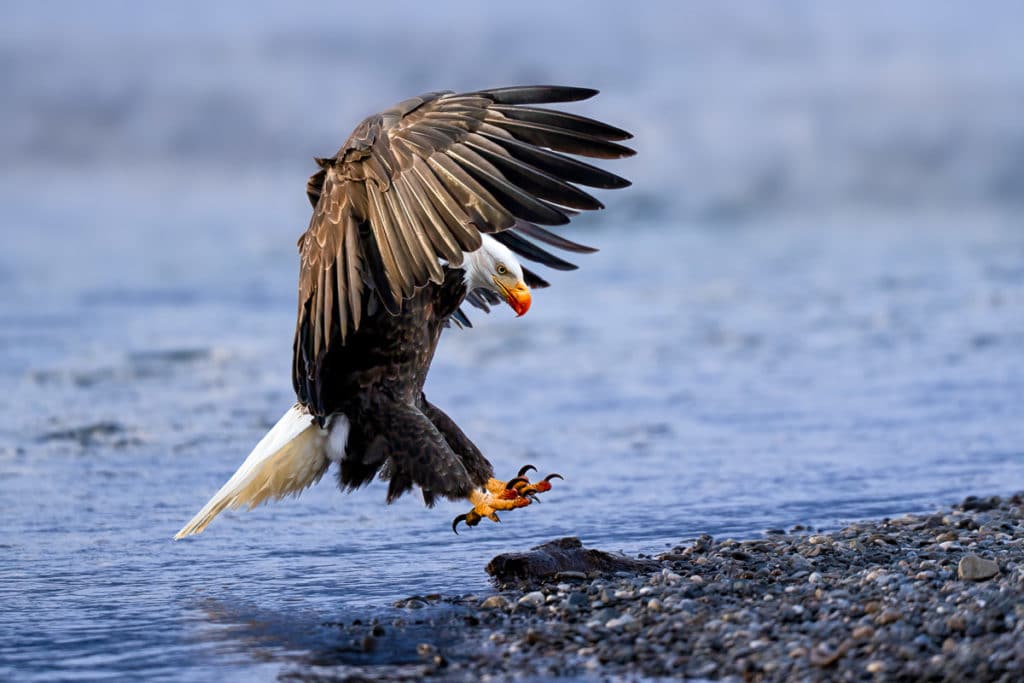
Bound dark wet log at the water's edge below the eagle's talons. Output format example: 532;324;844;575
486;537;660;584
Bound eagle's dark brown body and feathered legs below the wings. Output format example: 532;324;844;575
293;267;493;505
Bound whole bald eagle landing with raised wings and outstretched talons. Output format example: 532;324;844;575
174;86;634;539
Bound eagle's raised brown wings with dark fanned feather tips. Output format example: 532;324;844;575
293;86;634;397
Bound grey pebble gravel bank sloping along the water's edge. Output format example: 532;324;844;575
284;494;1024;681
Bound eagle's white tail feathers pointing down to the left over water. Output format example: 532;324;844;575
174;405;333;541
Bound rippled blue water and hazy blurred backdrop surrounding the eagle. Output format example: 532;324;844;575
0;1;1024;680
